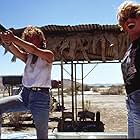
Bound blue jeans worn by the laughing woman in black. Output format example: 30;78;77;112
126;90;140;139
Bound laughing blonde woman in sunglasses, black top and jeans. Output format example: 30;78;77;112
117;1;140;139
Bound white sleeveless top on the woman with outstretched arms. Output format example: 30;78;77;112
22;54;52;88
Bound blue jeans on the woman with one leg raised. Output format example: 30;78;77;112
0;87;50;139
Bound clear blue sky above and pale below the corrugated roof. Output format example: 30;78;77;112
0;0;140;84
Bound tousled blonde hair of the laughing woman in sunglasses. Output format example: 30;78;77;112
117;0;140;30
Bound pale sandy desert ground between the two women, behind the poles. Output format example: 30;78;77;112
49;91;127;132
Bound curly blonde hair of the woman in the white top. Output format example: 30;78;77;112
21;25;46;48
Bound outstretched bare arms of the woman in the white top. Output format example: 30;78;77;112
2;31;54;63
